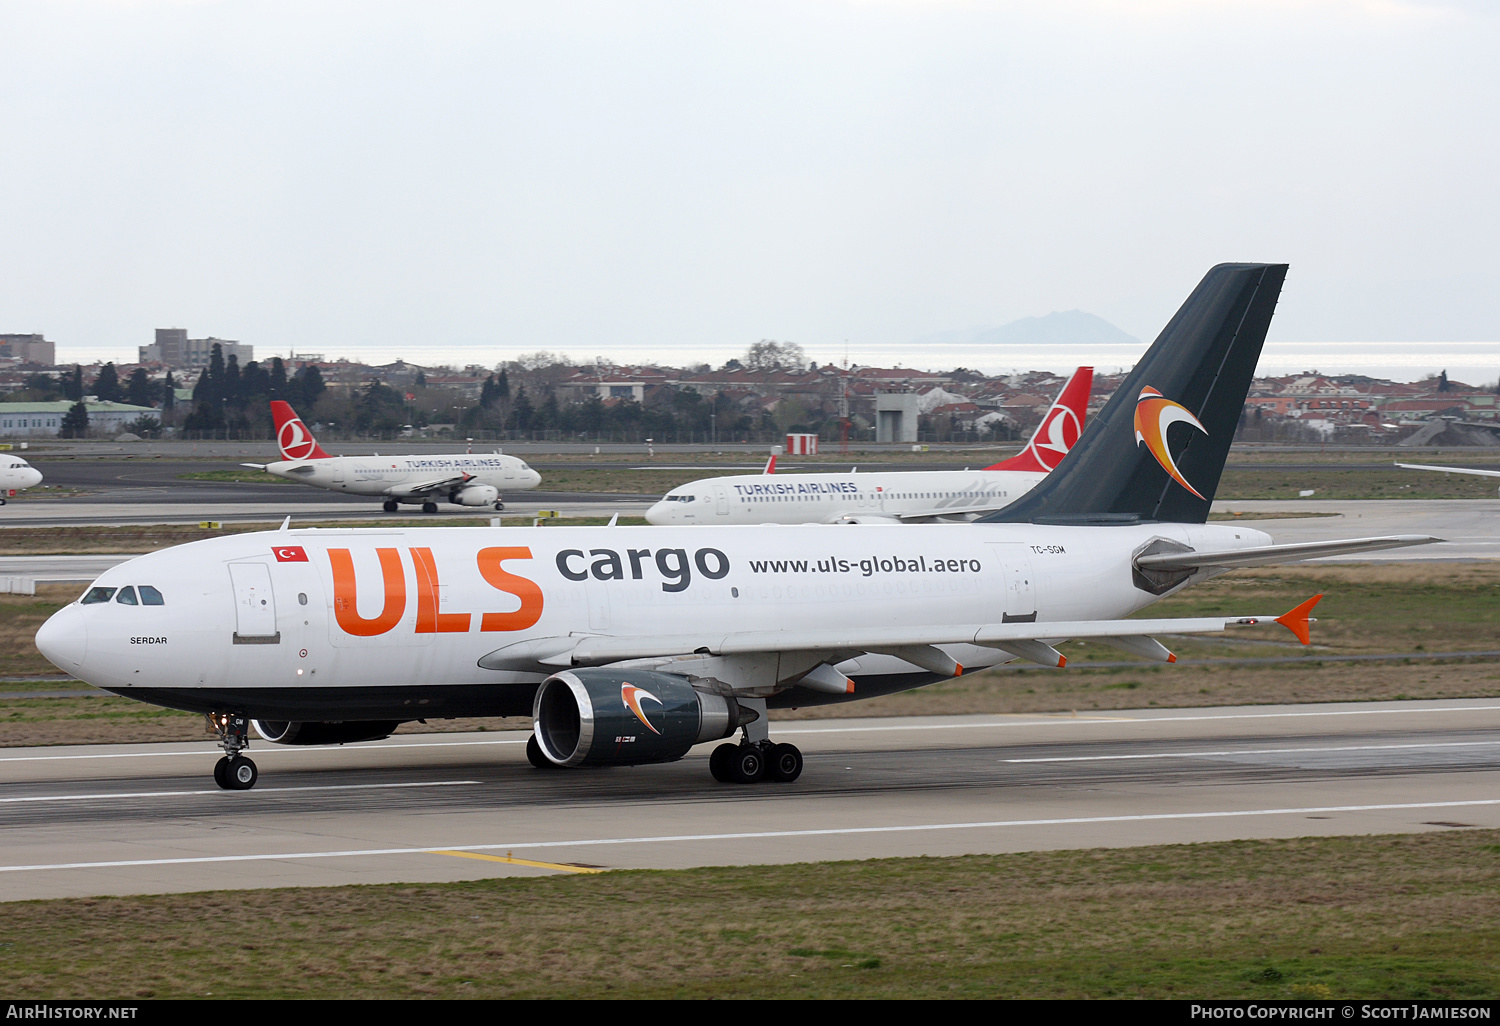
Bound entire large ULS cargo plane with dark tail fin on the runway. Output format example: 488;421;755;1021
36;264;1433;789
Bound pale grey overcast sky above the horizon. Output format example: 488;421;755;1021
0;0;1500;366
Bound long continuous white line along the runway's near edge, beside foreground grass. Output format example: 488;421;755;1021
0;798;1500;873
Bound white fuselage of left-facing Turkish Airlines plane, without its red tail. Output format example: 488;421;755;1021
647;470;1046;527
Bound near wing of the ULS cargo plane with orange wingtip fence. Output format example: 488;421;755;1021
479;596;1323;677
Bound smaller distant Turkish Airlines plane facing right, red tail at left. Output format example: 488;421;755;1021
242;399;542;513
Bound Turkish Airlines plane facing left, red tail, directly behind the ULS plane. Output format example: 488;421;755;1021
647;368;1094;525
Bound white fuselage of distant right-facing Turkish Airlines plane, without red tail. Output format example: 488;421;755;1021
266;453;542;498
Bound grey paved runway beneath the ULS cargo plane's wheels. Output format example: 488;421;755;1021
0;699;1500;900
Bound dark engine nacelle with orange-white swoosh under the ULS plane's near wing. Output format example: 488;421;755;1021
531;669;758;767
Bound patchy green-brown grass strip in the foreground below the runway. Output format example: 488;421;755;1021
0;830;1500;1001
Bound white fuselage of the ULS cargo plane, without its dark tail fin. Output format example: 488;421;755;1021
36;524;1269;720
